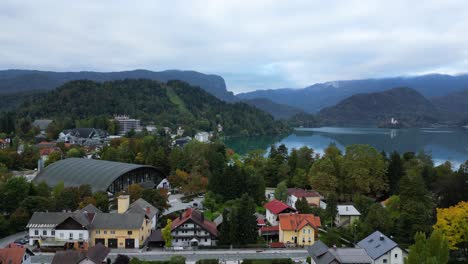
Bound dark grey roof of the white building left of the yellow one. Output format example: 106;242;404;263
27;212;90;227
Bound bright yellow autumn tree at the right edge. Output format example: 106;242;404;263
434;201;468;249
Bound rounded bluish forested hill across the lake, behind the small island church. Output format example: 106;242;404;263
318;88;441;127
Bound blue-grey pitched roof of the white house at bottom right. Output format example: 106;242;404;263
357;231;398;260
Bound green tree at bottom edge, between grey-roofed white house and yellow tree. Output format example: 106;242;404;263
405;230;449;264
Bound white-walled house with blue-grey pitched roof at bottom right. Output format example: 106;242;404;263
357;231;408;264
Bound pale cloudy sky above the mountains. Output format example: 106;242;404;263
0;0;468;93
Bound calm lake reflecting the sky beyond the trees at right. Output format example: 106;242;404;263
225;127;468;168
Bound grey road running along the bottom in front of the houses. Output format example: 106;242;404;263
32;249;308;263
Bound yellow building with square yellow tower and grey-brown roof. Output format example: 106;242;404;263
89;195;152;248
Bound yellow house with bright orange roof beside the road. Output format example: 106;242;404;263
279;213;321;246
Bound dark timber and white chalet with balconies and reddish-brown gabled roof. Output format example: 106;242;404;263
171;208;218;247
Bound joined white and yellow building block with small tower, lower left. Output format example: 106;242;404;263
26;196;155;250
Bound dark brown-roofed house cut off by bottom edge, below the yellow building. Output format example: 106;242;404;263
52;244;110;264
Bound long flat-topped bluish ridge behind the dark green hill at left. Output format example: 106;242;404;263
0;70;237;102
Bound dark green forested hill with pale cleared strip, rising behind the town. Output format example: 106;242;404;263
9;79;287;135
